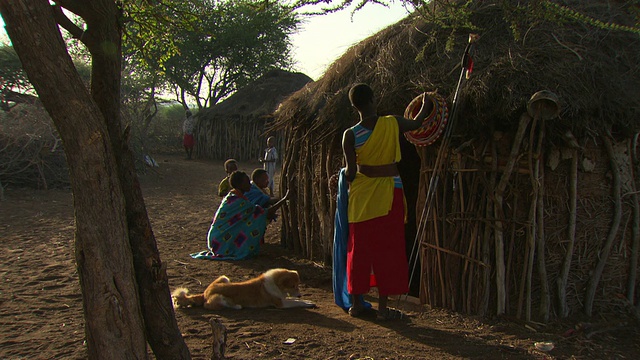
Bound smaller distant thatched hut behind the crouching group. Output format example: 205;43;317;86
196;69;312;160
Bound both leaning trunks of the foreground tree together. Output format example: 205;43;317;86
0;0;190;359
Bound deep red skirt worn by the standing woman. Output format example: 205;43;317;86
347;189;409;295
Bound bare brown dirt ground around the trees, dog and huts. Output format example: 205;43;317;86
0;155;640;359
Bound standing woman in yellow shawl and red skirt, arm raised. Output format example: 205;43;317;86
342;84;433;320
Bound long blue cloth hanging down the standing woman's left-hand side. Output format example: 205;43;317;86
332;168;371;310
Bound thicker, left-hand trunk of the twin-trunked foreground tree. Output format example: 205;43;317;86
0;0;147;359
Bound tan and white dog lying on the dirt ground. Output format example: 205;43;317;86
171;269;316;310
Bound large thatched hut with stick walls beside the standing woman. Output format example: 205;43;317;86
275;1;640;321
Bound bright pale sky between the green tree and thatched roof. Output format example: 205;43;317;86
0;1;408;80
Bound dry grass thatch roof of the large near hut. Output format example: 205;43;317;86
276;1;640;144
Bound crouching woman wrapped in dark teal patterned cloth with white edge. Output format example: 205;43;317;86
191;171;289;260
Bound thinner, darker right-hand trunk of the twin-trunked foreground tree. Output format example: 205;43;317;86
80;0;190;359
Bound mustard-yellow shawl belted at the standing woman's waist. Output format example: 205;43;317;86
348;115;401;223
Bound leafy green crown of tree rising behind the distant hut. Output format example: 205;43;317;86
125;0;299;108
